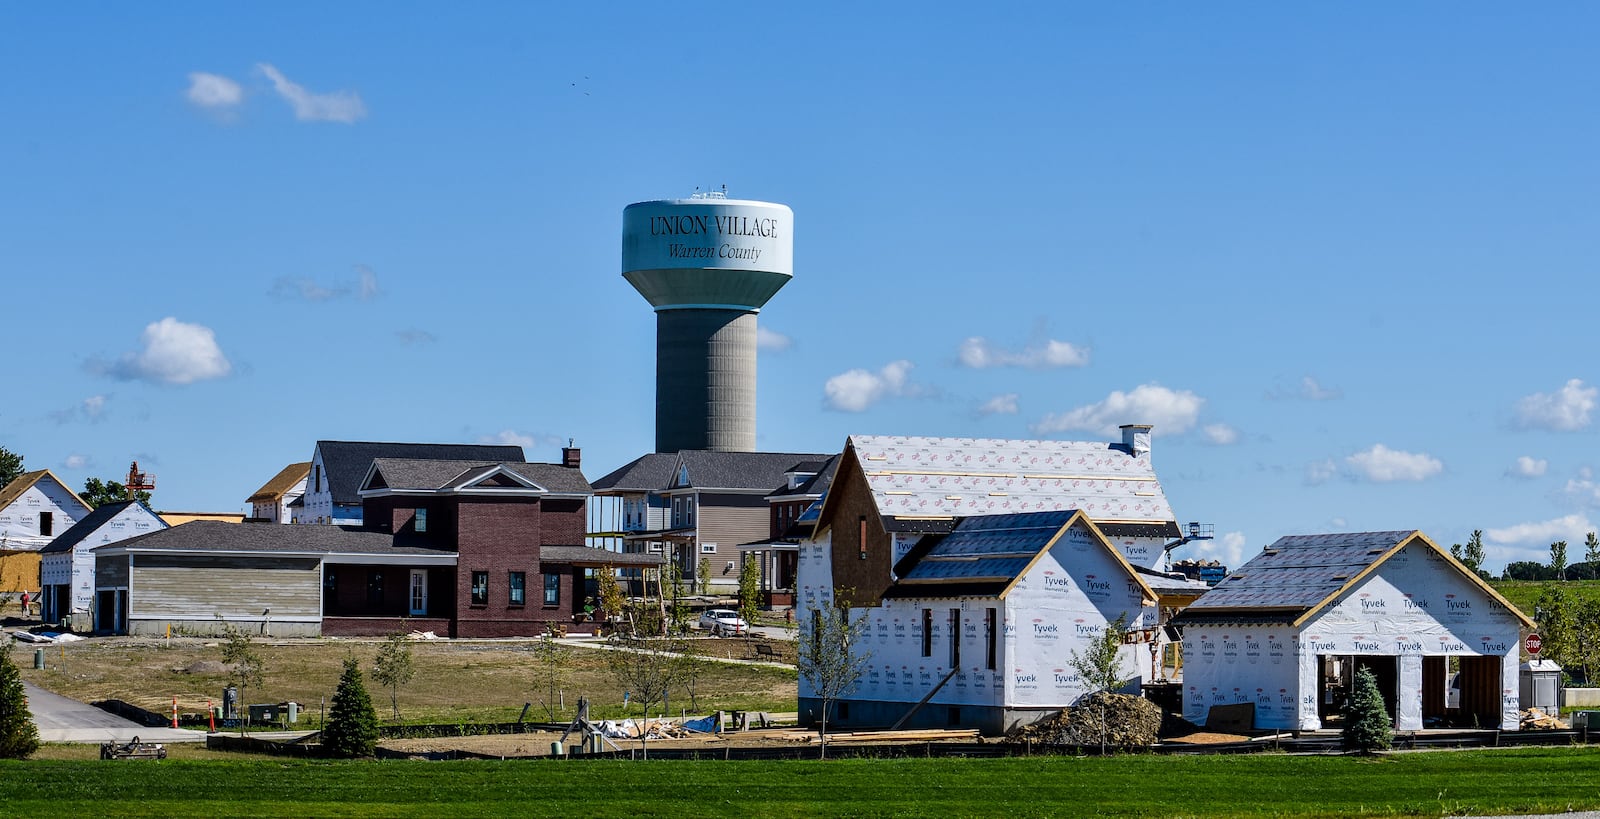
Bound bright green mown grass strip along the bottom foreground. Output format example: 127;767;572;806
0;749;1600;817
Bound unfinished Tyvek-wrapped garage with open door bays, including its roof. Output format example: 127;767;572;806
1173;531;1533;731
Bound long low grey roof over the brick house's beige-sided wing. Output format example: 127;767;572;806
94;520;456;557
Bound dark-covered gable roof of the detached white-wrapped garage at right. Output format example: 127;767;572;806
1178;529;1533;629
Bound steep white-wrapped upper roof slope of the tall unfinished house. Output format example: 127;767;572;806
821;435;1178;534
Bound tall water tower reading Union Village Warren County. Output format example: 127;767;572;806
622;194;794;453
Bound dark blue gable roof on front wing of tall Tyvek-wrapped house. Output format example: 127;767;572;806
890;510;1158;605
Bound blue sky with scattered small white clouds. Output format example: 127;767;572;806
0;2;1600;568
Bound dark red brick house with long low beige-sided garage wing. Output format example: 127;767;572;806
94;448;661;637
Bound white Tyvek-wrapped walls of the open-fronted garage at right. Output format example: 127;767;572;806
1184;542;1520;731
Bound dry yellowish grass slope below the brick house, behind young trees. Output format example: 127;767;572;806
13;638;795;723
